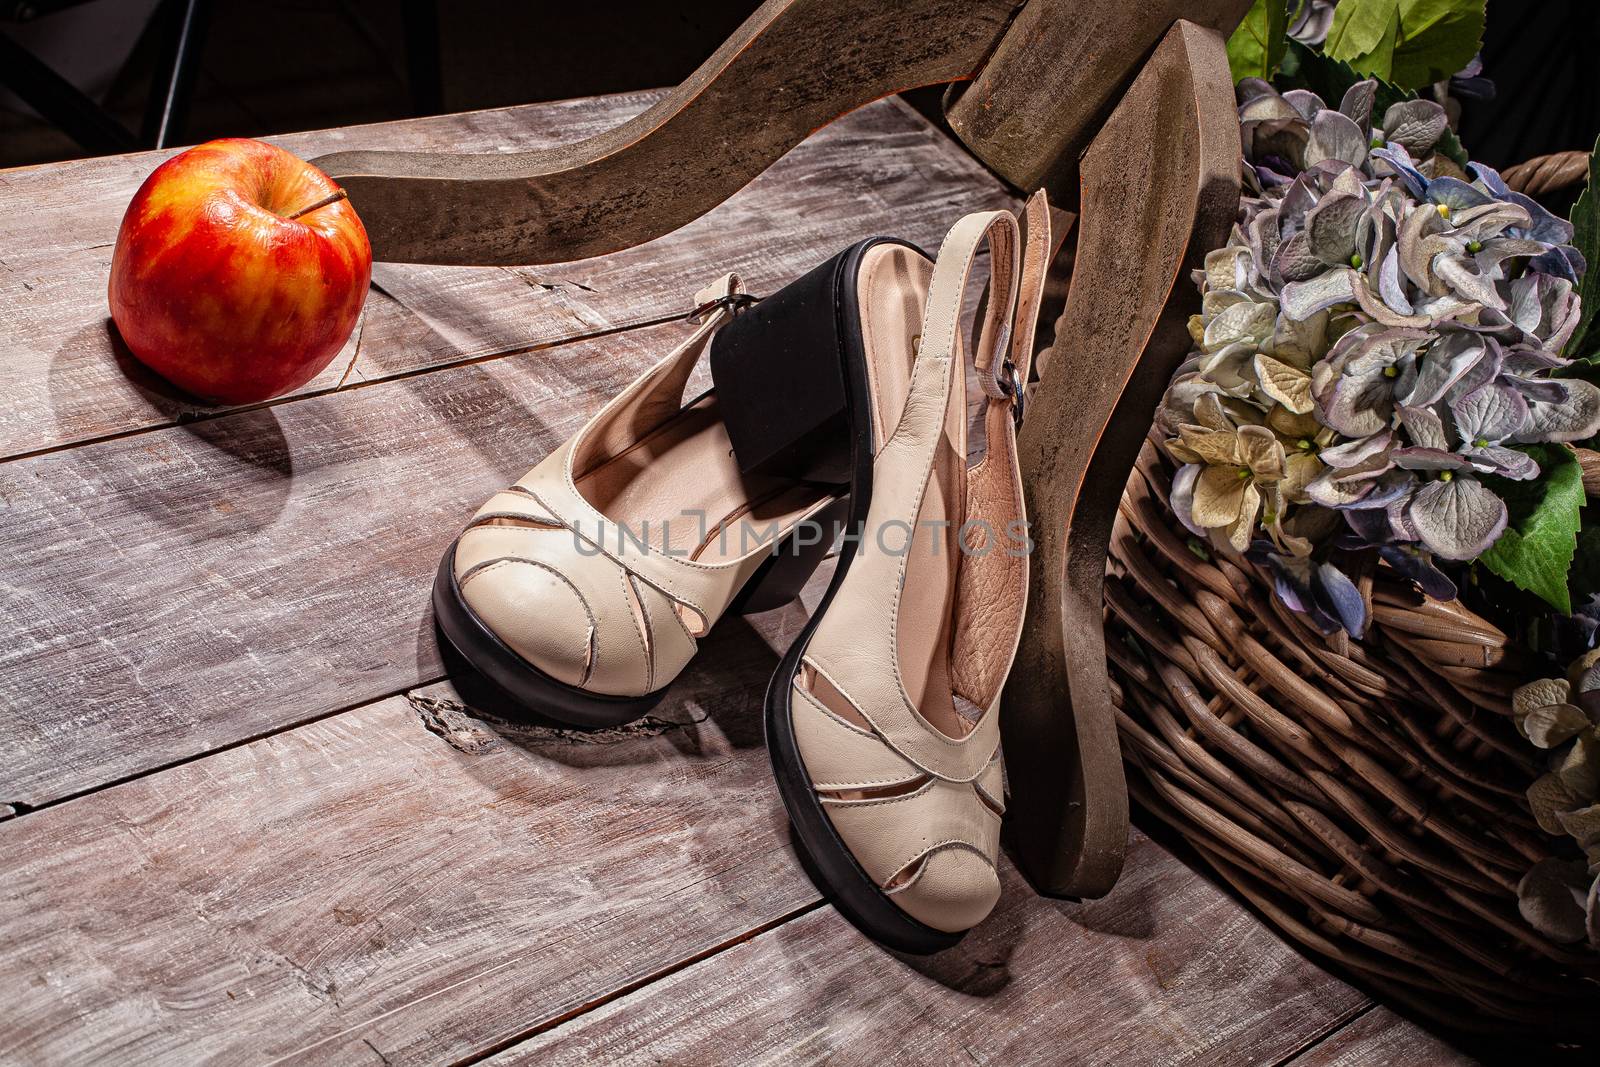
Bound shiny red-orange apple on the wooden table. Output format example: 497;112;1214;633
110;138;373;403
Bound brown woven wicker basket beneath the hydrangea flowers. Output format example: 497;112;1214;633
1106;154;1600;1041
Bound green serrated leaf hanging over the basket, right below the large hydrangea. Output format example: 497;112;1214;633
1478;445;1584;614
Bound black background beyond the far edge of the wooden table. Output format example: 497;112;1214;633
0;0;1600;177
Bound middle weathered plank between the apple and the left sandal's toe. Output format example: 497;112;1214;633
0;323;690;805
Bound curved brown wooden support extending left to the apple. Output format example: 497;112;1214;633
312;0;1019;266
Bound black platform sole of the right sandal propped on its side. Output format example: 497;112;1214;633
745;238;962;955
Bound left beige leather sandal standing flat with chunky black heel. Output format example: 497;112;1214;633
434;238;928;726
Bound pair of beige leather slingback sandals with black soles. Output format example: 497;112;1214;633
434;195;1051;952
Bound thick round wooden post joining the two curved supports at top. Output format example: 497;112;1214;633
946;0;1251;195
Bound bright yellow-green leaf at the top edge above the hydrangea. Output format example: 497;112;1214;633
1323;0;1483;90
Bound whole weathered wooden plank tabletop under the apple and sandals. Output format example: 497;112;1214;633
0;94;1466;1067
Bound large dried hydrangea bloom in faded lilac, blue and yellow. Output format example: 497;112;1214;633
1158;80;1600;633
